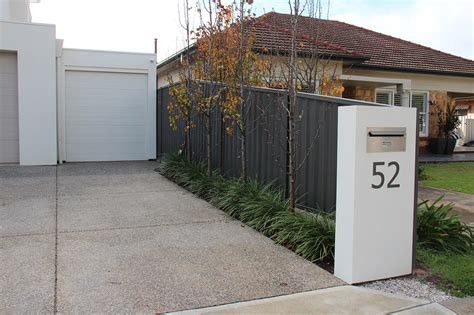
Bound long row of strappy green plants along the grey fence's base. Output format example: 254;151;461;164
159;155;335;262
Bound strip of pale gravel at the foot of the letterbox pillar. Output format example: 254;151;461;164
361;277;452;302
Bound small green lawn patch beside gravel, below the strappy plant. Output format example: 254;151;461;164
417;249;474;297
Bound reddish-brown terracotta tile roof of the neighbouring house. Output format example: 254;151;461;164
254;12;474;76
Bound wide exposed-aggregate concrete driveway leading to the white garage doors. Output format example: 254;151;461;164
0;162;342;313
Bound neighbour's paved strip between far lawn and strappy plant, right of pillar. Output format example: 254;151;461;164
418;186;474;226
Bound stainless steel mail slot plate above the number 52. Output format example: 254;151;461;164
367;127;406;153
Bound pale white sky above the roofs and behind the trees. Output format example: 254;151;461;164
31;0;474;60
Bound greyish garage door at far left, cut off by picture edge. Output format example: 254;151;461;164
0;52;19;163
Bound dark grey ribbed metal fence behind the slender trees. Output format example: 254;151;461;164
157;87;376;211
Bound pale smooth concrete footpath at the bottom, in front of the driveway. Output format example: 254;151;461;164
172;286;455;315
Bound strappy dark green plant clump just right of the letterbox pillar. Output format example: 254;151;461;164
417;196;473;254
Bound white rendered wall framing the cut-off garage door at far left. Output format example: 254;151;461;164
0;21;57;165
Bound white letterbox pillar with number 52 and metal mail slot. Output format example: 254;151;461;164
334;106;417;284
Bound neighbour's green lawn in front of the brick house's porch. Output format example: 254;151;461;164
420;162;474;194
